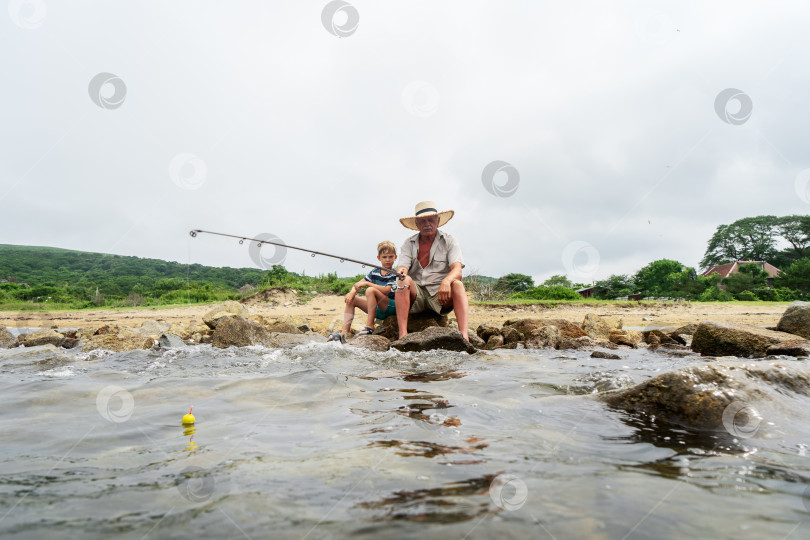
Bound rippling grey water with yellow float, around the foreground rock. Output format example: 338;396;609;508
0;343;810;539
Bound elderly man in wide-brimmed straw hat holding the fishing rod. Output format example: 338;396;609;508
394;201;470;341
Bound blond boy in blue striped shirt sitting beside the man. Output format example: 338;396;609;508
328;241;397;342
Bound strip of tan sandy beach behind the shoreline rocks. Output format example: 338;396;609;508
0;291;788;331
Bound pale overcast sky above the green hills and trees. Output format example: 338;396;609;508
0;0;810;282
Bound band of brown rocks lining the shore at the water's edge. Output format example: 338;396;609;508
0;301;810;358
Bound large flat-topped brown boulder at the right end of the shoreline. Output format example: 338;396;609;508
692;321;796;358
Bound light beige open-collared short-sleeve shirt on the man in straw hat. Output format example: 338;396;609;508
398;230;464;296
